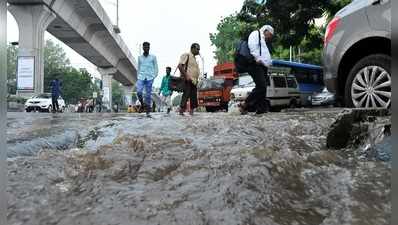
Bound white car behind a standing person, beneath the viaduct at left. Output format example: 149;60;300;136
25;93;65;112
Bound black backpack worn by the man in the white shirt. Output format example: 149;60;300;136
234;31;261;73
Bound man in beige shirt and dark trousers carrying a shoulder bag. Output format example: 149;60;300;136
178;43;200;116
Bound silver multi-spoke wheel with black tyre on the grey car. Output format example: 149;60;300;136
345;54;391;108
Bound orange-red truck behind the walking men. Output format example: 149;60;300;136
198;63;239;112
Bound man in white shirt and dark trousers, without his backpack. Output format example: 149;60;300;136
240;25;274;114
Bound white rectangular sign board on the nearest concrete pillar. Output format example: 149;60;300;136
17;57;35;90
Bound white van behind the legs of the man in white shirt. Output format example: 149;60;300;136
231;70;301;110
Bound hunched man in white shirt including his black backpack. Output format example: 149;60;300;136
235;25;274;114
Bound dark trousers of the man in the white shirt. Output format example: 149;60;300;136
245;65;269;113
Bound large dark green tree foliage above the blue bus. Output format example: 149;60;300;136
210;0;351;64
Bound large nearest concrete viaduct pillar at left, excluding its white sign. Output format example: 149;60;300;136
8;4;56;97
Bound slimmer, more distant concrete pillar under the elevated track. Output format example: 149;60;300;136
98;68;117;111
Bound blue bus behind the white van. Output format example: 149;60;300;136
272;60;325;105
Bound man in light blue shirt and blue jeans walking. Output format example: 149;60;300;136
136;42;158;117
